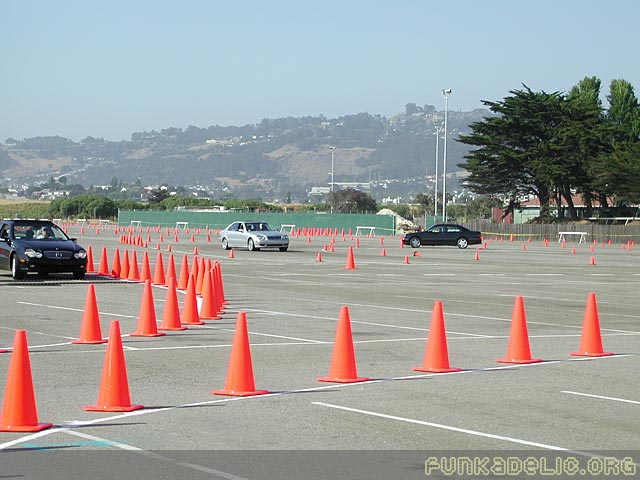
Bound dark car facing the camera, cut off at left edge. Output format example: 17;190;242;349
0;220;87;280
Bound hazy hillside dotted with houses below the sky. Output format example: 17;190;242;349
0;106;490;200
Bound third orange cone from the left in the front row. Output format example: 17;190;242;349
211;312;269;397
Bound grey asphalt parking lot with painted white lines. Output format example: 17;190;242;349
0;226;640;479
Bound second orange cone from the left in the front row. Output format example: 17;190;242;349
82;320;143;412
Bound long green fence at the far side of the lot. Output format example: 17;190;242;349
118;210;396;235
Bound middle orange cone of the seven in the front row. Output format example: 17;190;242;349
318;305;369;383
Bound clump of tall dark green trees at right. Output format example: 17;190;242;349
457;77;640;219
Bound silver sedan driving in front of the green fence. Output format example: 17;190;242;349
218;222;289;252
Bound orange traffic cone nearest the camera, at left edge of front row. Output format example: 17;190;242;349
0;330;53;432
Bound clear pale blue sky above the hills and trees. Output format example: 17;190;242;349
5;0;640;142
